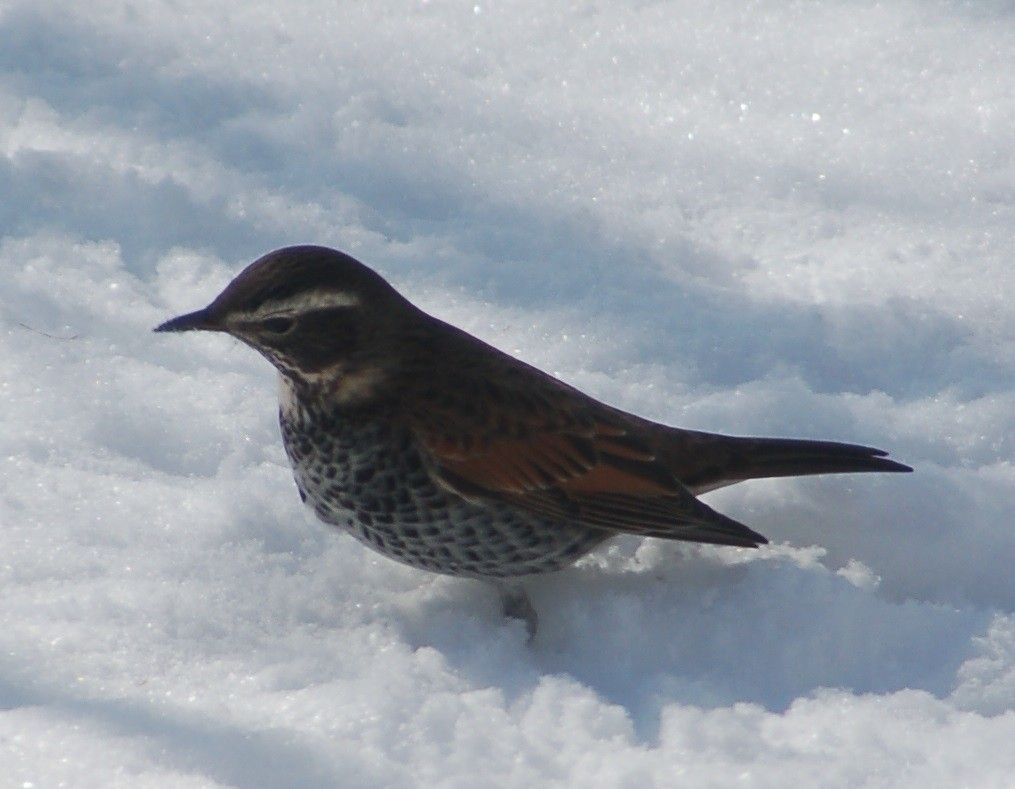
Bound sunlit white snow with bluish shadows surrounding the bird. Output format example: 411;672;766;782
0;0;1015;787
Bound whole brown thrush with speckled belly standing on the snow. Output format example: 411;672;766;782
154;246;912;640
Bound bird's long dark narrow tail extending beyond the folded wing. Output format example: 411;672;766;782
681;436;912;494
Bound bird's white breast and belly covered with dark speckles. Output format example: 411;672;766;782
279;400;609;577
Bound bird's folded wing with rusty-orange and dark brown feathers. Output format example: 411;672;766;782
401;379;767;547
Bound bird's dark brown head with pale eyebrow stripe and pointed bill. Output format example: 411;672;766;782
155;246;416;398
